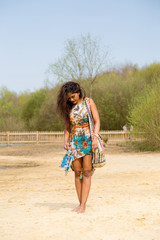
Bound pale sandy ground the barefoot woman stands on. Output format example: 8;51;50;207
0;144;160;240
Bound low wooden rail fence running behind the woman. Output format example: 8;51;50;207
0;131;140;145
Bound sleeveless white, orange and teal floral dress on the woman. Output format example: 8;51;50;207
69;98;92;160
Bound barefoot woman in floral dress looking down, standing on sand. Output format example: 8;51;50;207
57;82;100;213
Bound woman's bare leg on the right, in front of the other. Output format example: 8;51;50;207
77;155;92;213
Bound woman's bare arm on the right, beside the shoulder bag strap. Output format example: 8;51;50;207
90;99;100;150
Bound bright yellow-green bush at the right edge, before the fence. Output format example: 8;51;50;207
129;83;160;149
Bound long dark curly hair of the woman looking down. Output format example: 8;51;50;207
56;82;86;125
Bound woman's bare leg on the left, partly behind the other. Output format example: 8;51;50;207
72;158;82;212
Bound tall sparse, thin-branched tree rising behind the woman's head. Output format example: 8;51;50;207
49;34;108;96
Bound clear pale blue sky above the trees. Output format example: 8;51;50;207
0;0;160;93
